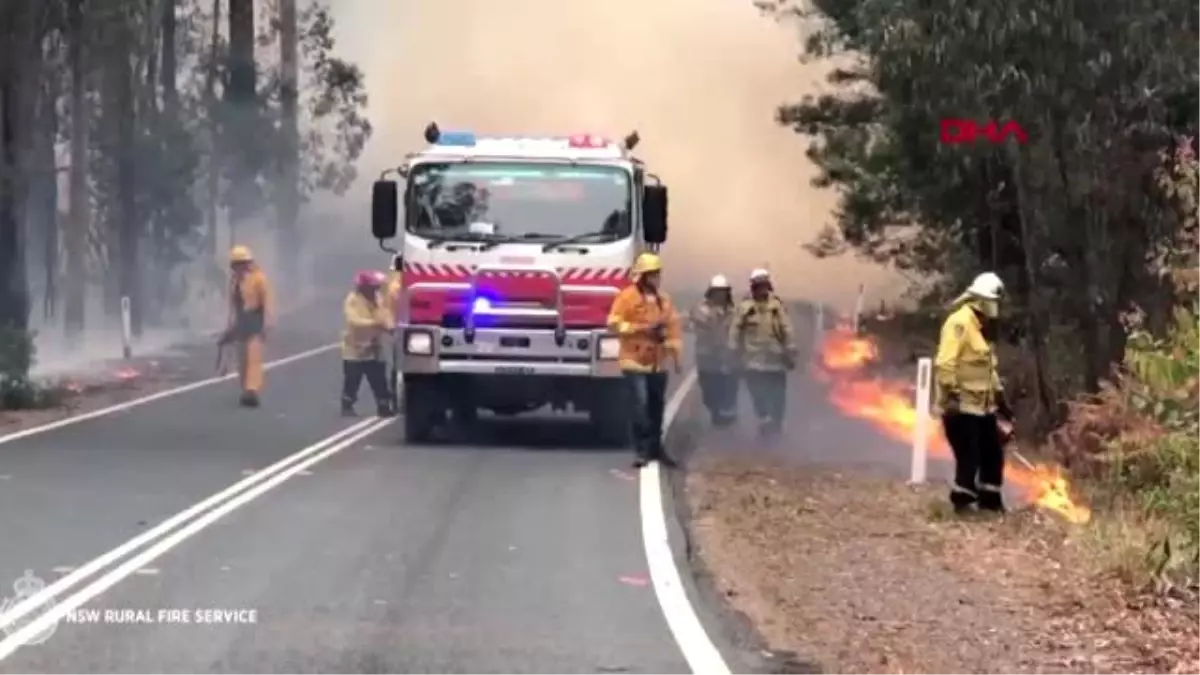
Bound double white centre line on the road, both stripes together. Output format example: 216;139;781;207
0;417;391;661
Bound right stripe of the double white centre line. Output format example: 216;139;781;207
0;418;392;661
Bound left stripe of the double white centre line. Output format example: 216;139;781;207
0;418;378;629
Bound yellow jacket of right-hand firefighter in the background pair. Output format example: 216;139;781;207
728;295;798;371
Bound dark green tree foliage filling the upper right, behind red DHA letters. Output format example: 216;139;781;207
758;0;1200;410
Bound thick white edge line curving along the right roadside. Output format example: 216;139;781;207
638;371;732;675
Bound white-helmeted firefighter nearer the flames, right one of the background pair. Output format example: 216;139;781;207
728;269;798;437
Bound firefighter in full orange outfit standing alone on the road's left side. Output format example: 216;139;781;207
222;246;275;407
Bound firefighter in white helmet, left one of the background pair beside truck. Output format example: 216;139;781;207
688;274;738;426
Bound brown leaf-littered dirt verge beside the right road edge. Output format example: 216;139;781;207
686;439;1200;675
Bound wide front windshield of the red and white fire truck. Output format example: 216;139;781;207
404;162;632;241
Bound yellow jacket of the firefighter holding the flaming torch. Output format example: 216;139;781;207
934;303;1003;414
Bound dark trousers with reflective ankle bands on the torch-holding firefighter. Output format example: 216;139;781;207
942;413;1004;510
